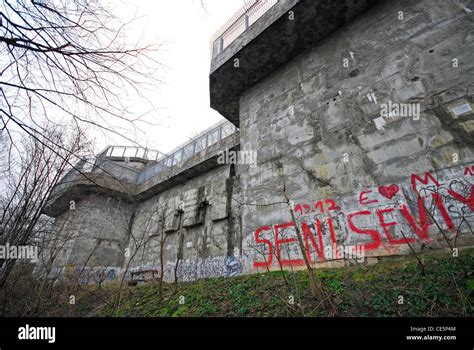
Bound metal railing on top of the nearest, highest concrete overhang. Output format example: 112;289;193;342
211;0;278;56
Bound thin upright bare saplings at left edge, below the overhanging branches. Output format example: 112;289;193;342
0;126;86;287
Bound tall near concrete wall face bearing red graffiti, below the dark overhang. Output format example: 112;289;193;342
238;1;474;271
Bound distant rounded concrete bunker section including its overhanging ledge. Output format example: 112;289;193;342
36;129;241;283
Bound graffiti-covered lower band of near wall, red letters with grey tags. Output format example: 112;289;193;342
252;166;474;268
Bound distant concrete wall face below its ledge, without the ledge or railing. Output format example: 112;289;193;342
38;161;242;283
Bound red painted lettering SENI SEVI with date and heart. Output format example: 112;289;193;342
254;166;474;267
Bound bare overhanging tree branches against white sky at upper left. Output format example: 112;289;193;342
0;0;159;164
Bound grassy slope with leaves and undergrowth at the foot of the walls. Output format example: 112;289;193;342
1;249;474;317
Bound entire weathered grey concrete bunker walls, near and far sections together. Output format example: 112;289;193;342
38;0;474;281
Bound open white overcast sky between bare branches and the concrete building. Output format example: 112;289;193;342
95;0;244;153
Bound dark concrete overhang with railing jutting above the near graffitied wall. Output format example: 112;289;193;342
209;0;378;127
